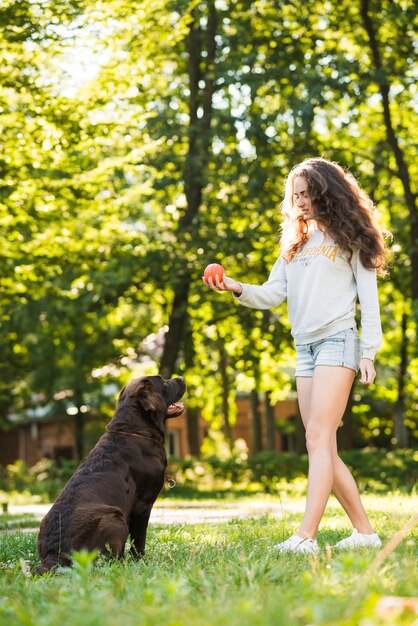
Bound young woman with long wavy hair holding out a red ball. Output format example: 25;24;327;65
204;158;386;553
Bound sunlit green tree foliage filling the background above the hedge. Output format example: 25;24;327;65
0;0;418;447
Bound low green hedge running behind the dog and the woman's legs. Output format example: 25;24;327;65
0;448;418;503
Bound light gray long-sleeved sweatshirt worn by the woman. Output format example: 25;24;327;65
238;230;382;359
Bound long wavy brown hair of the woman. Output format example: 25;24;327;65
281;157;387;273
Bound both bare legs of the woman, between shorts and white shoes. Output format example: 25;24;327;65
297;366;373;538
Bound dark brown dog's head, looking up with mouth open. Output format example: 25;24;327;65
106;376;186;432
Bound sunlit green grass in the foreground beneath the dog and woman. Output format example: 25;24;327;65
0;494;418;626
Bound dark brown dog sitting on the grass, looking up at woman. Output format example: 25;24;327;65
38;376;186;574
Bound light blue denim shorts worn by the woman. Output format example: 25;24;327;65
296;328;361;376
